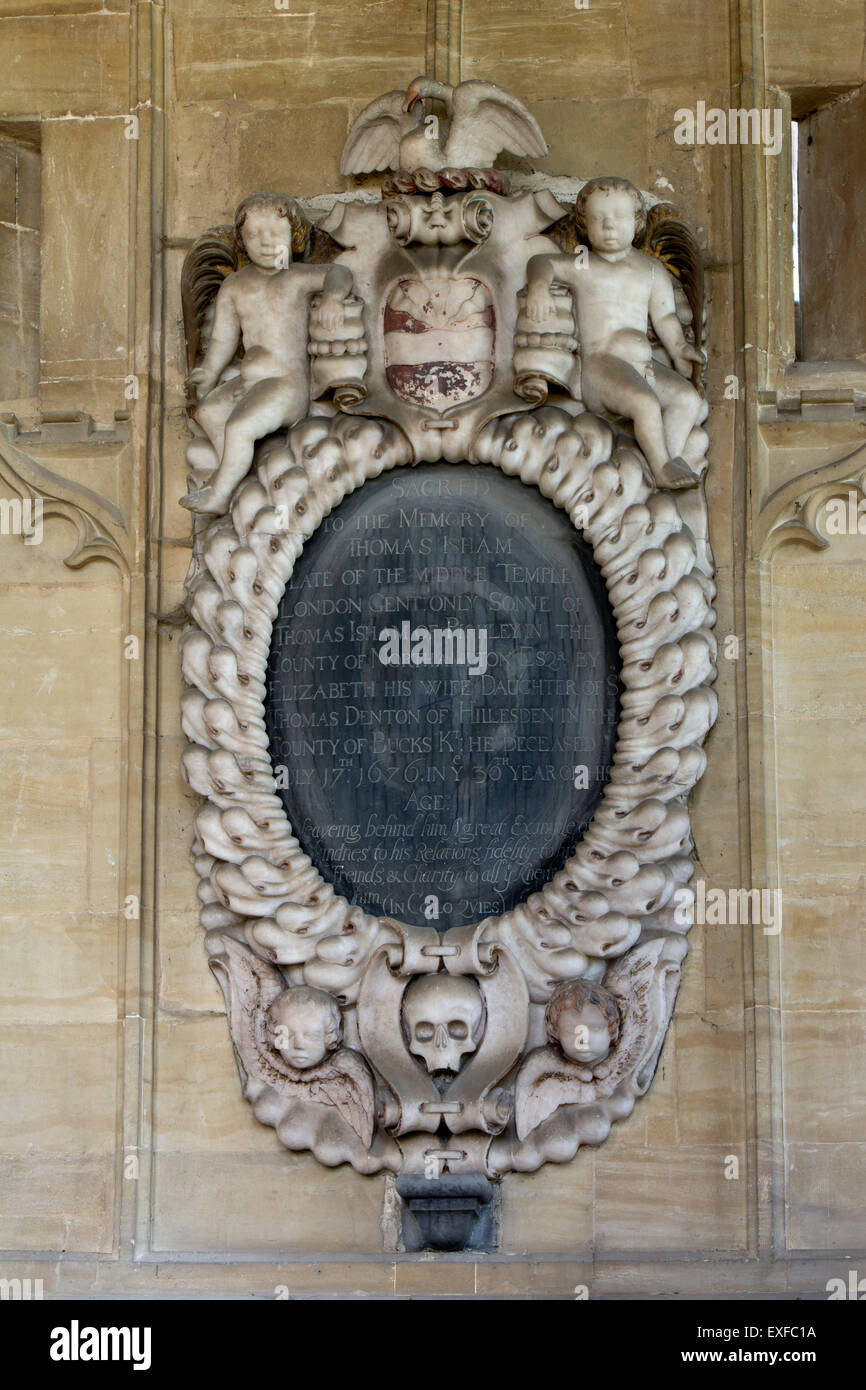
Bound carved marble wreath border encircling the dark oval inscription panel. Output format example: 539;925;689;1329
182;406;717;1005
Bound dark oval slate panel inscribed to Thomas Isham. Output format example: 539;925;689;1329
265;464;620;930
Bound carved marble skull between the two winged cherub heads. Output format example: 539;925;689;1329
403;974;484;1073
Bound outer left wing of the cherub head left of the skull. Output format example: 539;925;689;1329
210;935;285;1101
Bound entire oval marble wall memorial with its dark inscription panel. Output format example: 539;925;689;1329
182;78;716;1248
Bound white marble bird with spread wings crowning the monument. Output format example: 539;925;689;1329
339;76;548;174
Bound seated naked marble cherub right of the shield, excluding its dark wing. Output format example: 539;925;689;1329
525;178;706;488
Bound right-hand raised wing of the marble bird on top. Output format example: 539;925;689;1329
445;81;548;168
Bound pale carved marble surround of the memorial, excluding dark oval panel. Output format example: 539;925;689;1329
181;78;716;1179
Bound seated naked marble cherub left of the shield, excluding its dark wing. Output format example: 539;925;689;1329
181;193;352;514
